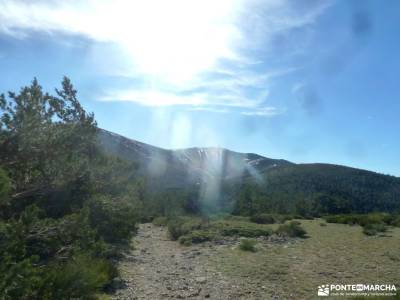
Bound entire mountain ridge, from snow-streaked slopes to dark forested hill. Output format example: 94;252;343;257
99;129;400;214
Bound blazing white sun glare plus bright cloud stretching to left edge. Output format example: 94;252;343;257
1;0;244;83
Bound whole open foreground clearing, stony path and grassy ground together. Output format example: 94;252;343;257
112;219;400;300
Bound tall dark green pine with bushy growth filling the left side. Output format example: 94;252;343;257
0;78;143;299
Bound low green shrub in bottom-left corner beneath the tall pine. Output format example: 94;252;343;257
0;206;117;299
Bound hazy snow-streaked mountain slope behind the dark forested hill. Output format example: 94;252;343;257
99;129;293;188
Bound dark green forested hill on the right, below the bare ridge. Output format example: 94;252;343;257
228;164;400;218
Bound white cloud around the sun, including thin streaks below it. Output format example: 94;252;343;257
0;0;330;110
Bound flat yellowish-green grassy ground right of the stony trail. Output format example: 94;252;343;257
207;220;400;299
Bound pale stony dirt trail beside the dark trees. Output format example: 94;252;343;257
113;224;259;300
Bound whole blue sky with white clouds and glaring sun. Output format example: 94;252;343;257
0;0;400;176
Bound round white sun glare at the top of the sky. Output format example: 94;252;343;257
103;0;240;83
